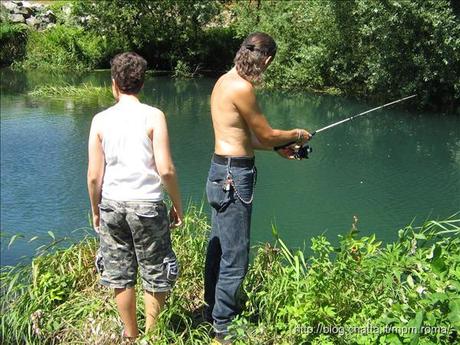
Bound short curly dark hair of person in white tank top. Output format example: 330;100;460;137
110;52;147;95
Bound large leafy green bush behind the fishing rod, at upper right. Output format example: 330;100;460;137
233;0;460;110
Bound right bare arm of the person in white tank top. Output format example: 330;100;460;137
153;111;183;226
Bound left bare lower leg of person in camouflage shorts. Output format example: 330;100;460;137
115;287;139;338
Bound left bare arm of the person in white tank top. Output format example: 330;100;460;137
87;117;105;231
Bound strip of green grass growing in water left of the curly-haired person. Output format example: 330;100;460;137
29;84;113;99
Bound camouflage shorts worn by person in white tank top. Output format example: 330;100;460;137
99;199;179;292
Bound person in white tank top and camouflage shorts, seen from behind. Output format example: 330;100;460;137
88;53;183;338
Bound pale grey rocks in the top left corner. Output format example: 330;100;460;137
1;1;56;30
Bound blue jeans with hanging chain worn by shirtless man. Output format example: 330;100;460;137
204;155;257;335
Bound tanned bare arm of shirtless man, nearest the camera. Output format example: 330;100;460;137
234;84;311;149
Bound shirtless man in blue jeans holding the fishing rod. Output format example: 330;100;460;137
205;32;311;343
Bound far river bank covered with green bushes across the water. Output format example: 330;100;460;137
0;0;460;110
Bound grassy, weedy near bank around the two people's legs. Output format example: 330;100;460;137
0;208;460;344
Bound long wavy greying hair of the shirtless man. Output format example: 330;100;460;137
234;32;276;82
